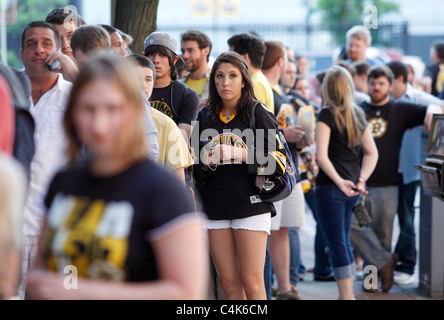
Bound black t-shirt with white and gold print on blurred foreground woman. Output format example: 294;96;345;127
44;160;196;282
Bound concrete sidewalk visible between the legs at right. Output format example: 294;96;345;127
297;202;433;300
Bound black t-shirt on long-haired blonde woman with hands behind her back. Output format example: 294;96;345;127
316;108;362;185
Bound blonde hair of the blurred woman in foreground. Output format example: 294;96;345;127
63;54;148;163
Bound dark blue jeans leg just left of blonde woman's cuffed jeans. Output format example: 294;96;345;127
305;191;332;278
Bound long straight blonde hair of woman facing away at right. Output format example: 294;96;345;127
322;66;366;147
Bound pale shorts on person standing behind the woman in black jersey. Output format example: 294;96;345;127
271;183;305;231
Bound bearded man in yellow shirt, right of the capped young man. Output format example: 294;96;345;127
180;30;213;110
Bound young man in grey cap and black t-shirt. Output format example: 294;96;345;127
144;32;200;144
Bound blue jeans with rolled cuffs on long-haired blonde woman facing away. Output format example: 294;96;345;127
315;185;359;280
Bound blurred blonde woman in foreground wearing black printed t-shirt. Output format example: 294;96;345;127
28;55;208;300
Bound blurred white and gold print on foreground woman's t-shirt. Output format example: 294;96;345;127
45;194;134;281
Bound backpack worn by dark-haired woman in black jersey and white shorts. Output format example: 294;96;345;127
250;103;297;202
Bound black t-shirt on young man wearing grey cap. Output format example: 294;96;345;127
150;81;200;125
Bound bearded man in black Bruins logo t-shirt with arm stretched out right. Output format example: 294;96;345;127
350;65;442;292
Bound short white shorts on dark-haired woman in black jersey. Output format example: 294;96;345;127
205;213;271;234
